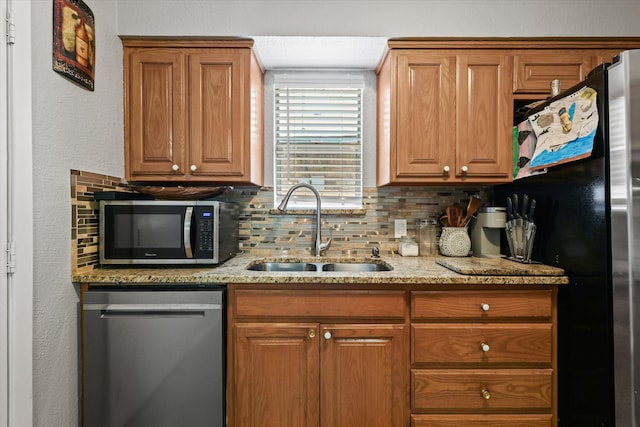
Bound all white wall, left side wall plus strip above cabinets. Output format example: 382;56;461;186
27;0;640;427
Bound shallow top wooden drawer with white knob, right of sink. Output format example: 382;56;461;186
411;289;553;320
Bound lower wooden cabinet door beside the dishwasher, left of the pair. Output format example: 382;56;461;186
233;323;320;427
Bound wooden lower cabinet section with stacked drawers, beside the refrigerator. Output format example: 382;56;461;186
411;288;557;427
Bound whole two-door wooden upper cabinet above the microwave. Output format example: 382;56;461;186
123;39;263;185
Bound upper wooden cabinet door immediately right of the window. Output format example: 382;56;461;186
391;51;456;182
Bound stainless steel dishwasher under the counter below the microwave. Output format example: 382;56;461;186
82;288;225;427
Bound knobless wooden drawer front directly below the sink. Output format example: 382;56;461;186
231;289;405;319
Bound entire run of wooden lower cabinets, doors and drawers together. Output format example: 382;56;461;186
227;284;557;427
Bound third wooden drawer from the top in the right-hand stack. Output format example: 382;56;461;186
411;369;553;412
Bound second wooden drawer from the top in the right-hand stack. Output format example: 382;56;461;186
411;323;552;367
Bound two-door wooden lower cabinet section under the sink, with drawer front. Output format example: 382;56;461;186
229;290;409;427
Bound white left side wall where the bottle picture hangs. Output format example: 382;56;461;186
30;0;124;427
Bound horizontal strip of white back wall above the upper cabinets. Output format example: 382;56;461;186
118;0;640;37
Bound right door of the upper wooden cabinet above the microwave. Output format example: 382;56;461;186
189;49;249;178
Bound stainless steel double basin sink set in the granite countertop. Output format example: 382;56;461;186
247;261;393;273
